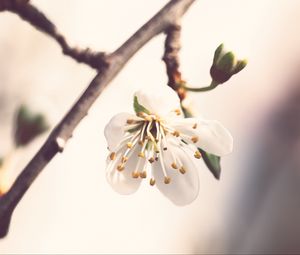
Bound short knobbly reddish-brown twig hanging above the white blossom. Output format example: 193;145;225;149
163;22;186;100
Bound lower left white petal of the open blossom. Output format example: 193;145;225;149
106;146;142;195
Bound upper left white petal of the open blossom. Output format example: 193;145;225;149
104;112;138;151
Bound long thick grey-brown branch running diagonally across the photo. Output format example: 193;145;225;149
0;0;195;237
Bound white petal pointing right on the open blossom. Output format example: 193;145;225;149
171;118;233;156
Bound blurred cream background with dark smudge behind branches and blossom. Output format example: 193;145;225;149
0;0;300;254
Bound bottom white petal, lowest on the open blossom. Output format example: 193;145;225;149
152;140;199;206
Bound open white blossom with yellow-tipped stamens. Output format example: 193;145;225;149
104;86;232;205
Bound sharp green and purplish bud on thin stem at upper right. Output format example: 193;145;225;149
210;44;247;84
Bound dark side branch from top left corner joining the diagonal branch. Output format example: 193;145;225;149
0;0;107;70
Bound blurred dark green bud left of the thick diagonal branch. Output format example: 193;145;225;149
14;105;49;147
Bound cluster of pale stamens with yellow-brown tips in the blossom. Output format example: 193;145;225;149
110;111;201;186
